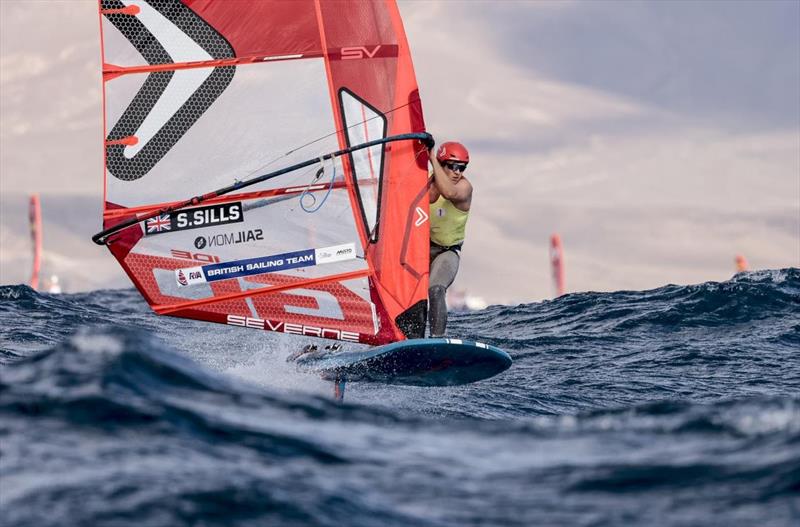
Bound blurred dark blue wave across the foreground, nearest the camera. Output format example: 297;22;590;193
0;328;800;525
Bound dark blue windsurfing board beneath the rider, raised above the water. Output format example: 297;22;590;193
296;338;511;386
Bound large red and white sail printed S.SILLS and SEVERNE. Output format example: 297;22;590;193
93;0;430;344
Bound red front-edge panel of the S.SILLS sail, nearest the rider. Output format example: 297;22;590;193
323;1;429;338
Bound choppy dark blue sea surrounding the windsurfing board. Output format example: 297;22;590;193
0;268;800;527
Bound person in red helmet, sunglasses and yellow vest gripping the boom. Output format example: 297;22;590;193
428;141;472;337
